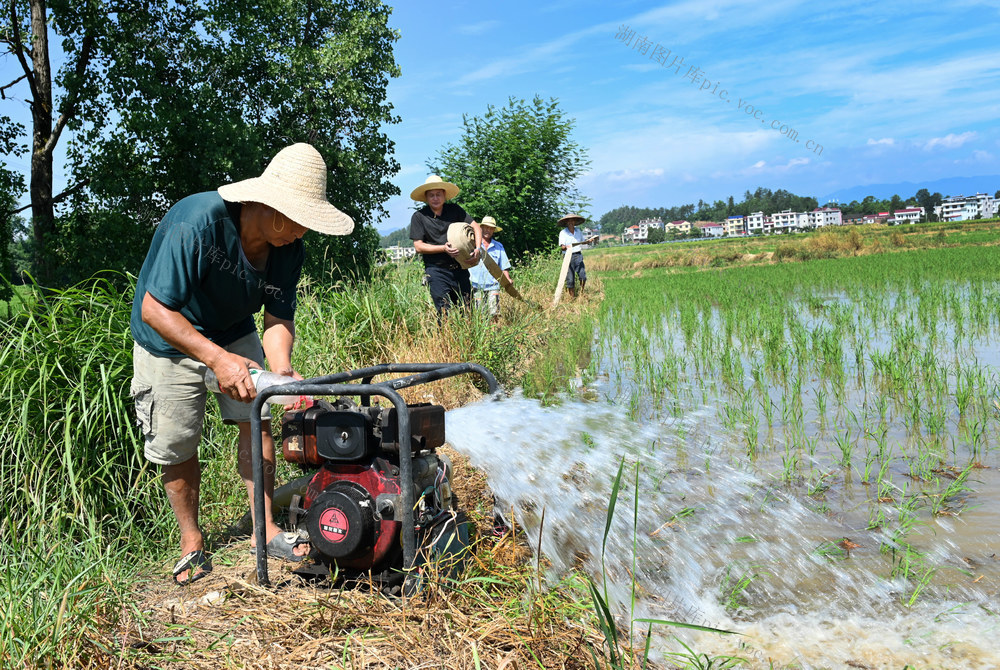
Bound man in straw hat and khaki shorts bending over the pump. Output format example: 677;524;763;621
131;144;354;585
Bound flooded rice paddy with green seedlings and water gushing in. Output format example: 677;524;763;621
448;248;1000;668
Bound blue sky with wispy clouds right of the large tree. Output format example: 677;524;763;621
379;0;1000;232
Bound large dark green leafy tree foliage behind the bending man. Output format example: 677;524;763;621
4;0;399;281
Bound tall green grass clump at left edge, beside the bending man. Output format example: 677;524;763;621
0;281;162;667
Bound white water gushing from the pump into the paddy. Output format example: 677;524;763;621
447;396;1000;669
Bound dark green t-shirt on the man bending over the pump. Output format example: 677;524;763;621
131;191;305;358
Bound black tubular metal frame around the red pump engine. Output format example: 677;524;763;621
250;363;500;592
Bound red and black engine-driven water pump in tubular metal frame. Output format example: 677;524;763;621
251;363;499;593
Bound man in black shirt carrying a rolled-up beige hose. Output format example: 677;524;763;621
410;174;483;317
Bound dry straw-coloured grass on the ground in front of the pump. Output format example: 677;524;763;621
115;447;603;670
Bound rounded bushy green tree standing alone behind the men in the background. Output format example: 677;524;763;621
427;96;584;259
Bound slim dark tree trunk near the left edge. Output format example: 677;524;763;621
30;0;55;285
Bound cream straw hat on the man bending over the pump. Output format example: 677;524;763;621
218;142;354;235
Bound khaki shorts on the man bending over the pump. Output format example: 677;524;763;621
132;333;271;465
